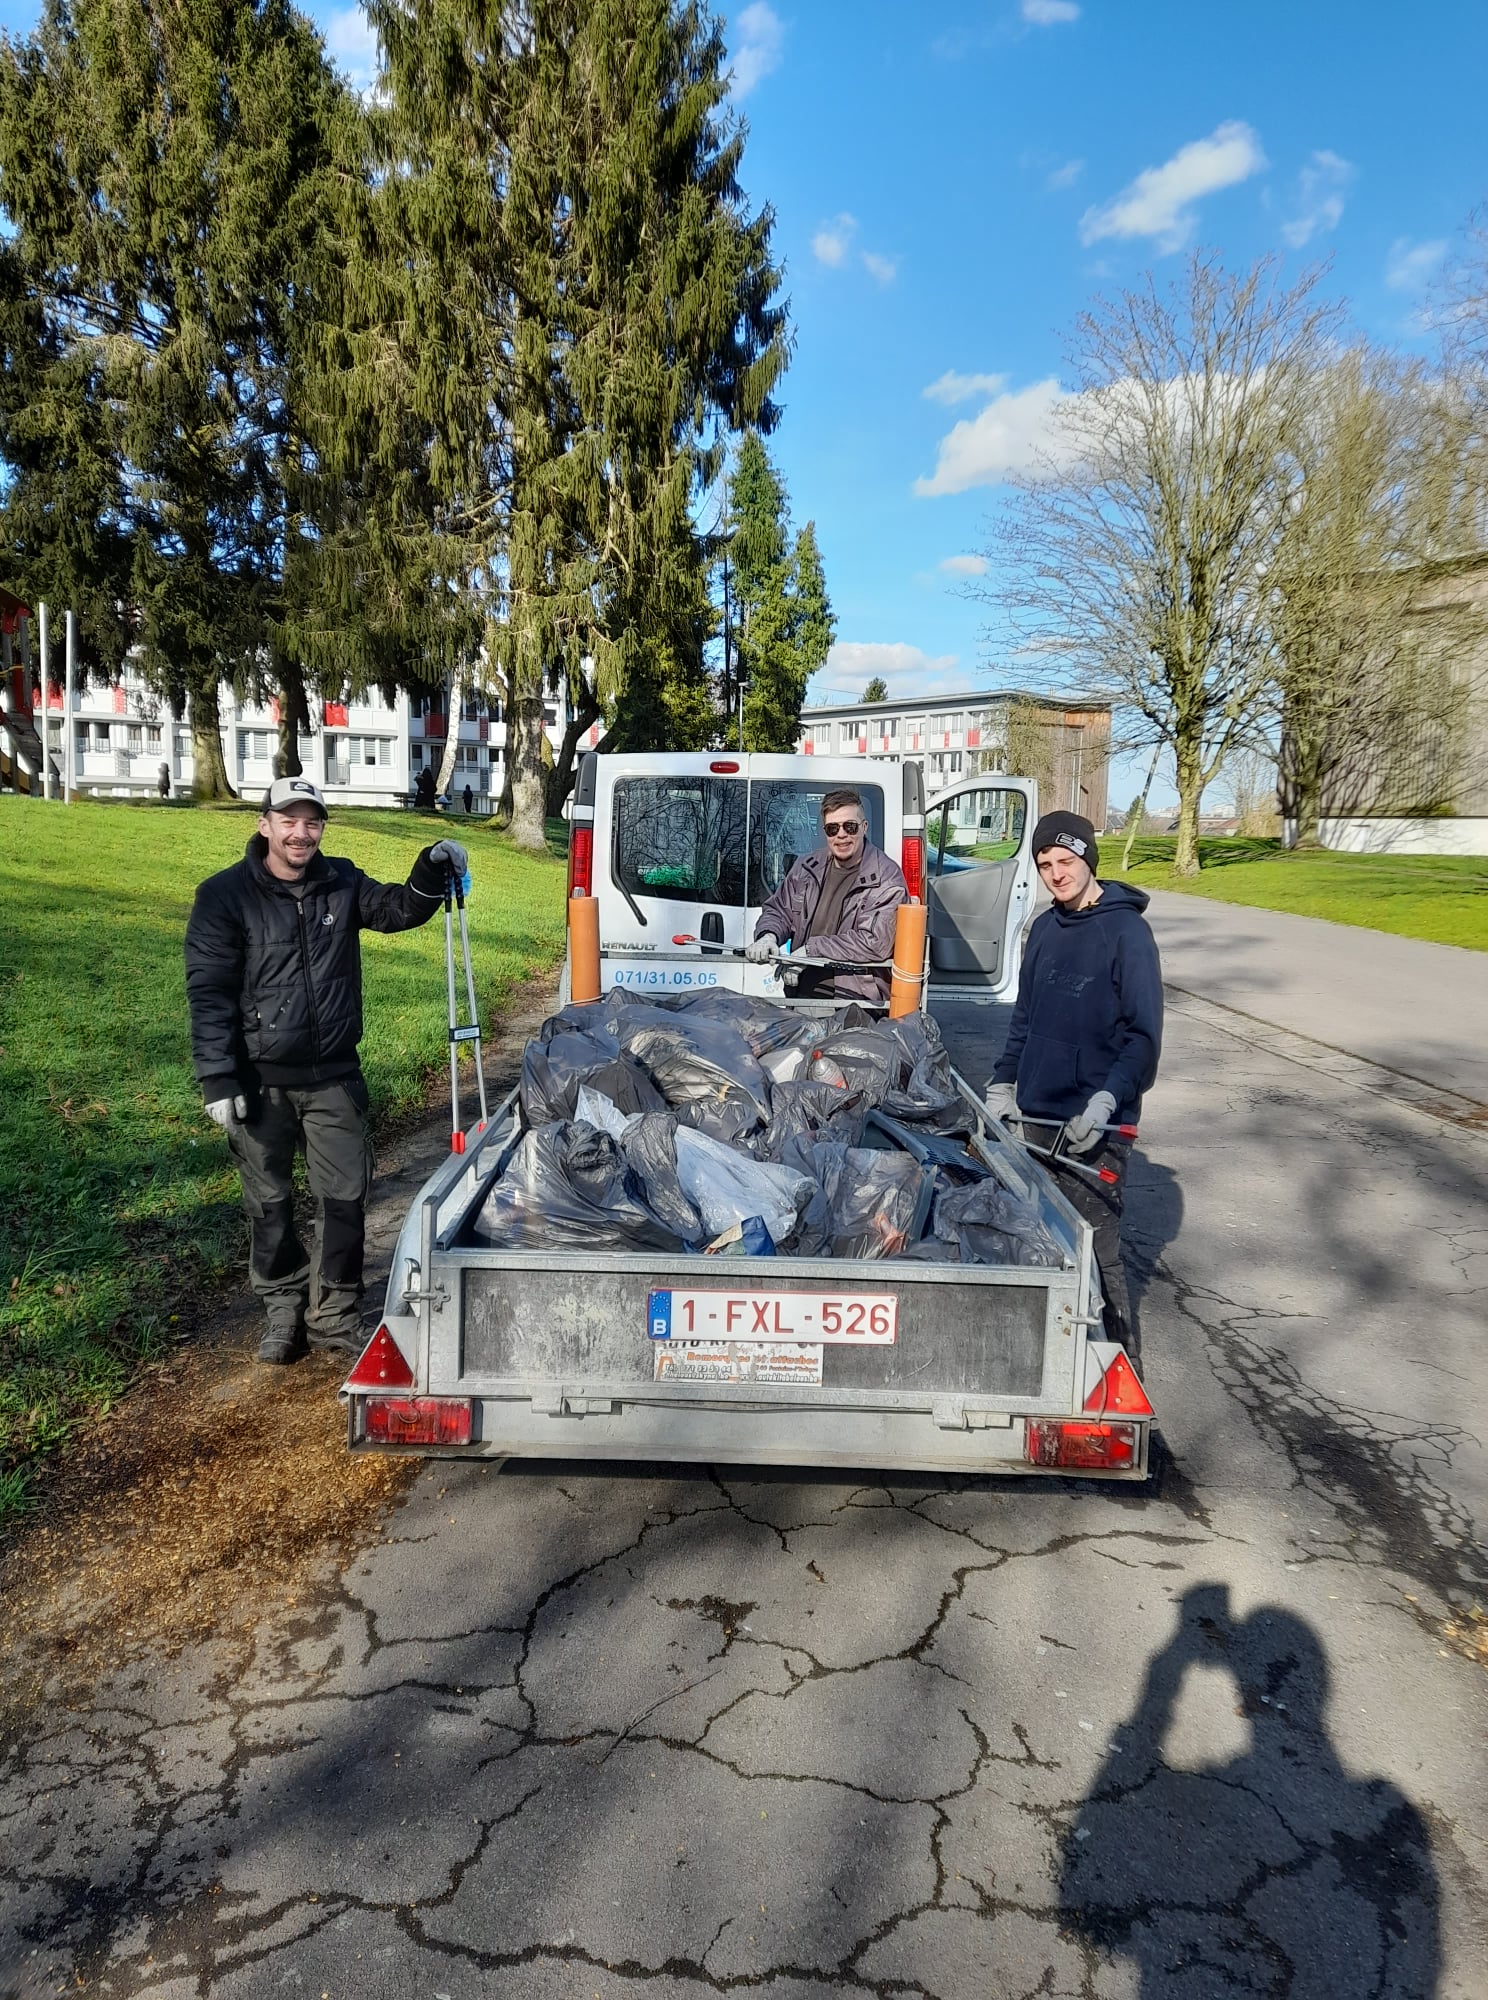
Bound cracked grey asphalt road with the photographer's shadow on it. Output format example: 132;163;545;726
0;996;1488;2000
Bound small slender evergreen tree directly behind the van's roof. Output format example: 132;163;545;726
728;432;836;752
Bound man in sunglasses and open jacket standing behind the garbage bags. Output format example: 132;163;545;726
744;790;910;1004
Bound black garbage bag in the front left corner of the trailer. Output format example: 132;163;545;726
474;1120;678;1250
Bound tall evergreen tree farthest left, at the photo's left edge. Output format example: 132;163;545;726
0;0;340;796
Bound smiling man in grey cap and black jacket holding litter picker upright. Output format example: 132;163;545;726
186;778;468;1362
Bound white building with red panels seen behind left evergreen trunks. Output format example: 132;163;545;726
23;668;598;814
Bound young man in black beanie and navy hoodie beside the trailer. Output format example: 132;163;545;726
986;812;1162;1358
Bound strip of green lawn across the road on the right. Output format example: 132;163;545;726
1102;834;1488;952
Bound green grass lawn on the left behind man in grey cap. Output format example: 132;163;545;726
0;796;564;1522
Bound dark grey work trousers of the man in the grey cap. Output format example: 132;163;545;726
228;1076;372;1346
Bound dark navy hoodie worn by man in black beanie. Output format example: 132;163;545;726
992;882;1162;1124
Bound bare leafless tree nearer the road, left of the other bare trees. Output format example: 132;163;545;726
978;254;1334;874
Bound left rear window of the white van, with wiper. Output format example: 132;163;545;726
612;778;744;904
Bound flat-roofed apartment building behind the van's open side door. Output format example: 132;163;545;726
798;690;1110;826
